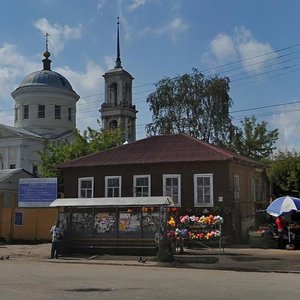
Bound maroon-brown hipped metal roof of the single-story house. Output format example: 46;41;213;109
58;133;262;169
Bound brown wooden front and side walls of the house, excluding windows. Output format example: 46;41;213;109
63;161;265;241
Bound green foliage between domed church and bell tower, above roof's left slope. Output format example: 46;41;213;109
39;127;122;177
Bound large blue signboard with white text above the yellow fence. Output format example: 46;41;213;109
19;178;57;207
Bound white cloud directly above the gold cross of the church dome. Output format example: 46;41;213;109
34;18;82;54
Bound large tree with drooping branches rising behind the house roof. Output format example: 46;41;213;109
146;69;232;144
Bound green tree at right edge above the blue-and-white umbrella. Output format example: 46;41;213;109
267;151;300;197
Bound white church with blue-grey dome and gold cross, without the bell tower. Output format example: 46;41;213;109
0;43;79;174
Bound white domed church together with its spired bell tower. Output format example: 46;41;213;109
0;22;137;175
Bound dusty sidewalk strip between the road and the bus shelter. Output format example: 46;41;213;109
0;244;300;274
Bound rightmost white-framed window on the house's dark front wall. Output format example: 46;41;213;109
194;174;213;207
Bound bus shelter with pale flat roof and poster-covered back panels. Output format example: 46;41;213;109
50;197;173;256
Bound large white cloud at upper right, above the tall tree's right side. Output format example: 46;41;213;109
204;26;277;74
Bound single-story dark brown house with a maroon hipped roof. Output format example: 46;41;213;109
58;134;267;241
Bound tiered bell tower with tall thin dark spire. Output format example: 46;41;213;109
100;17;138;142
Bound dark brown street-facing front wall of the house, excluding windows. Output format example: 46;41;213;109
63;162;230;208
